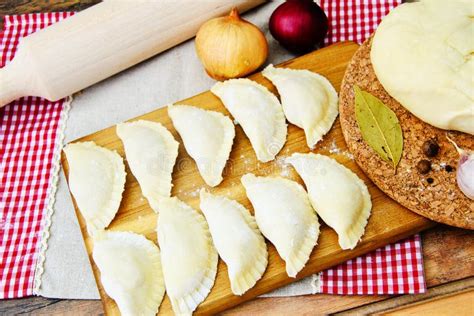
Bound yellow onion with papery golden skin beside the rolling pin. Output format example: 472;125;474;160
196;9;268;80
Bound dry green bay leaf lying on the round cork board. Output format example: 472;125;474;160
354;85;403;169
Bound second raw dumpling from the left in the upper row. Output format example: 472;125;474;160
117;120;179;206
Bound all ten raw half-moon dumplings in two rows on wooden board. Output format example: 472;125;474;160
64;65;371;315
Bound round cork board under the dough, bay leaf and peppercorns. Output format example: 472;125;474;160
339;38;474;229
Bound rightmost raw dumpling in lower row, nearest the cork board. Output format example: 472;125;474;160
287;153;372;249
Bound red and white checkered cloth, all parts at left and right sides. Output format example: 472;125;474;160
0;0;426;298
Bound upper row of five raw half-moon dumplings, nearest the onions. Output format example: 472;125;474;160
65;65;338;230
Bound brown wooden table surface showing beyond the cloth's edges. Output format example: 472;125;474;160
0;0;474;315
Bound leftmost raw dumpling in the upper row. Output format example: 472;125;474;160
64;142;126;235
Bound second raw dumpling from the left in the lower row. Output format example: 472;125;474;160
157;197;217;315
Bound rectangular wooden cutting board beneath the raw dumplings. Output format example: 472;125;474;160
62;42;434;315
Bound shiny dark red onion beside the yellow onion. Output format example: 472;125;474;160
269;0;328;53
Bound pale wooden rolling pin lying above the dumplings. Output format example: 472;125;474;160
0;0;265;107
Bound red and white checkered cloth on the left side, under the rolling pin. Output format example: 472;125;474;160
0;13;71;298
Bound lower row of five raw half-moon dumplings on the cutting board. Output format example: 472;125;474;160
67;162;371;315
